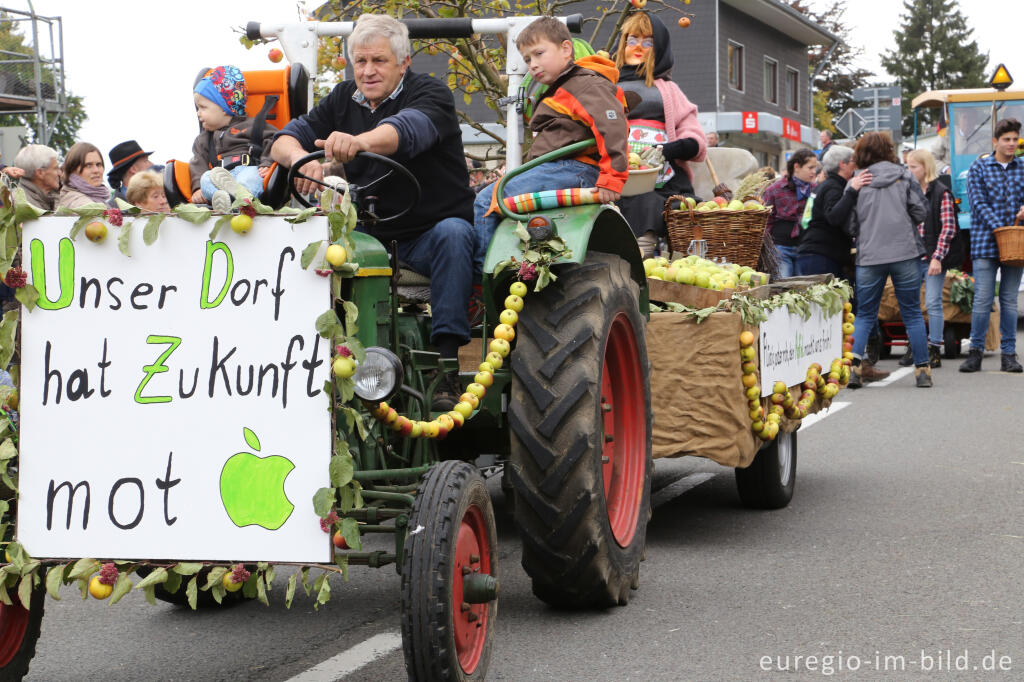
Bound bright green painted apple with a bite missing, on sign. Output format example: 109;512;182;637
220;427;295;530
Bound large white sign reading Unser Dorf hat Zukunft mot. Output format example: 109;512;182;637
17;216;332;562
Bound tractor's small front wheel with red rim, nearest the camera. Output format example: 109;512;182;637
401;460;498;682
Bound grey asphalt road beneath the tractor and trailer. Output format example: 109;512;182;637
19;339;1024;682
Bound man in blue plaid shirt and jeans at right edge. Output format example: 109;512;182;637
959;119;1024;372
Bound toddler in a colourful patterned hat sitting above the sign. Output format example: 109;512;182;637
188;66;276;213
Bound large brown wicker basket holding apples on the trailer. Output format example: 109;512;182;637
664;197;771;267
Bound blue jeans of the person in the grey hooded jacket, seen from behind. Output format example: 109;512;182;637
853;258;928;366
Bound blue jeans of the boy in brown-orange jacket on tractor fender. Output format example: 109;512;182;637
473;159;598;274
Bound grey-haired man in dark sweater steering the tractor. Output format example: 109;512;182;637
270;14;479;410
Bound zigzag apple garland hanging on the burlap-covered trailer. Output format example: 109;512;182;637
739;301;855;441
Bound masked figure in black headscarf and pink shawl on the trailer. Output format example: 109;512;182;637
615;12;708;258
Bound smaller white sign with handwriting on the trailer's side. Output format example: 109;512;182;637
758;303;843;395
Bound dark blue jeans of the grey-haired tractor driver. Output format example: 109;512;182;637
398;218;474;343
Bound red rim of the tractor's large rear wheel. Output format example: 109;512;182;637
601;312;647;547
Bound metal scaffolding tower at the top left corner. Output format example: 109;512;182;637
0;1;68;144
